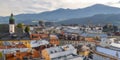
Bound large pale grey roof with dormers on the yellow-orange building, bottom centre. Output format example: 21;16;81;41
46;45;76;58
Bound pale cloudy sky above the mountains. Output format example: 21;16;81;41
0;0;120;16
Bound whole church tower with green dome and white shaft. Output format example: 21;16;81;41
9;14;15;34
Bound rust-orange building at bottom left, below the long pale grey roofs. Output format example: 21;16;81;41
5;49;40;60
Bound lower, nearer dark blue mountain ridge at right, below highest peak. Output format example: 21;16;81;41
57;14;120;26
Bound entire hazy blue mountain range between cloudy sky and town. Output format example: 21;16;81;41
0;4;120;24
